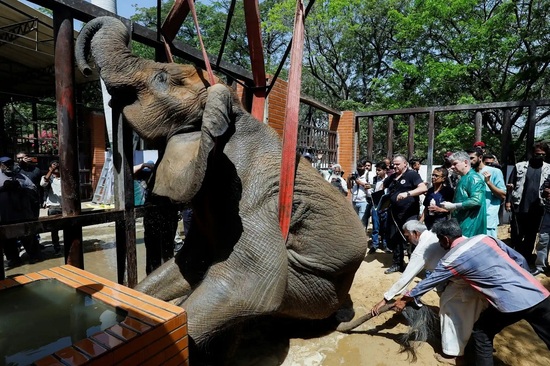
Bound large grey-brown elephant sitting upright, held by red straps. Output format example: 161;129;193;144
75;17;367;360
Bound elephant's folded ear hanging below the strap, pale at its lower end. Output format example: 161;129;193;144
153;84;234;202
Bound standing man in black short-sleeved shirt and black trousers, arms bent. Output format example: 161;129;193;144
384;155;428;274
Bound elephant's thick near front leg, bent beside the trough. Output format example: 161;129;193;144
182;225;288;349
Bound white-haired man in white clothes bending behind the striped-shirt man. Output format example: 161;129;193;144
371;220;487;364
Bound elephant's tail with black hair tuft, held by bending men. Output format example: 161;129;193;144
336;301;441;362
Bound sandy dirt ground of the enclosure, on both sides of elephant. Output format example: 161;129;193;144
6;222;550;366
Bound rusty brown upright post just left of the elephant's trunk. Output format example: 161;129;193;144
53;8;84;268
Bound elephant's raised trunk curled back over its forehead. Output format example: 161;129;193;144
75;17;143;95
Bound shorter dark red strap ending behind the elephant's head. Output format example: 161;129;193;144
244;0;267;121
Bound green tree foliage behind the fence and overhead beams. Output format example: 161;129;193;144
127;0;550;162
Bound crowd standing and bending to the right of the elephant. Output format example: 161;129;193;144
314;141;550;365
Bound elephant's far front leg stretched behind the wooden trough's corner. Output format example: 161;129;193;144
135;258;192;305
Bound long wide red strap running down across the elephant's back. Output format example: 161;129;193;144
279;0;304;242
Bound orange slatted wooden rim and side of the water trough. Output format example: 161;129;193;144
0;265;189;366
